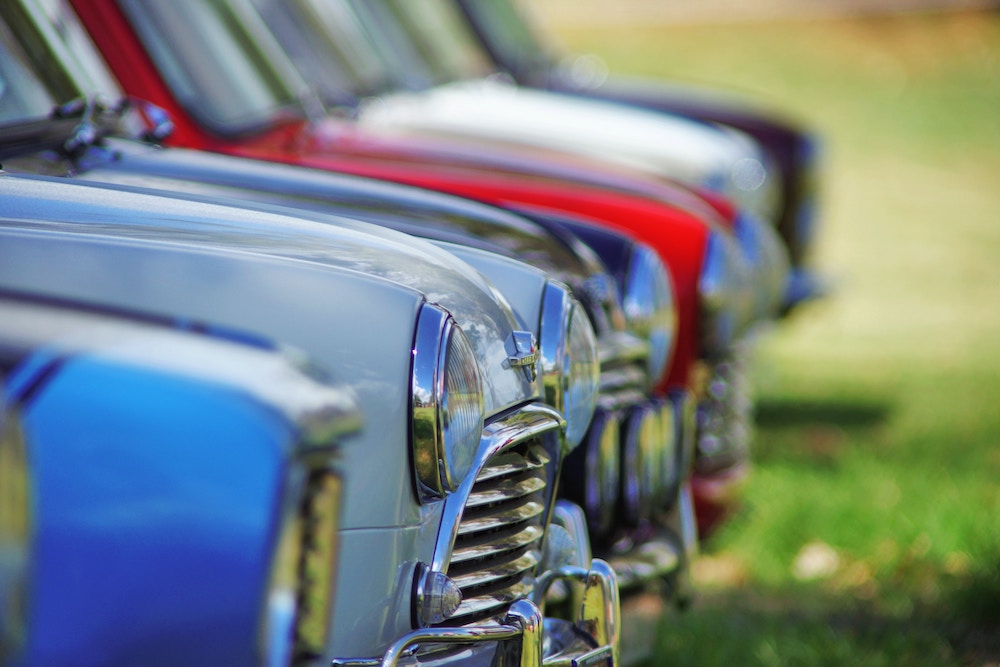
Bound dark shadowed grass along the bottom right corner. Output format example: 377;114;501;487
645;589;1000;667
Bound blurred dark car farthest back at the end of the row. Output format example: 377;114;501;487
456;0;824;310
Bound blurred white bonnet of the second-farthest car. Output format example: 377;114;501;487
360;81;764;201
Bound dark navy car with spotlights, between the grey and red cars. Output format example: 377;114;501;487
0;0;695;600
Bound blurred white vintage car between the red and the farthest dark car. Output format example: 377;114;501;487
266;0;780;226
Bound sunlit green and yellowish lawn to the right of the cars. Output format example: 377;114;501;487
544;6;1000;665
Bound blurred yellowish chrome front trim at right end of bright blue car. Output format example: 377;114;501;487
261;469;342;667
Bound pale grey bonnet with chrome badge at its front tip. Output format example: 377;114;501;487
0;174;538;413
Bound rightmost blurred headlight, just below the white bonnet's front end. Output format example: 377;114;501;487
733;212;789;320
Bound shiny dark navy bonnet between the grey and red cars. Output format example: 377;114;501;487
74;139;602;294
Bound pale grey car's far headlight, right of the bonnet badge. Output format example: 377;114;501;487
539;282;601;447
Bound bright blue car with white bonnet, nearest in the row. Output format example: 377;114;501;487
0;291;361;666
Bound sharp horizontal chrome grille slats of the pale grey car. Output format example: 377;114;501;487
447;439;553;626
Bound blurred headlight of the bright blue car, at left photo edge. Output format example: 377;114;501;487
0;404;31;661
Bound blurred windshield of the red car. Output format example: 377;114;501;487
120;0;305;134
